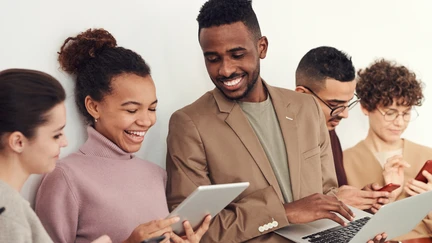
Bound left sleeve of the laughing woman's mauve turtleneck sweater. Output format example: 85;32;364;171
35;166;79;243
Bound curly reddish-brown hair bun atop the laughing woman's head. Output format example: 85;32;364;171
58;29;117;74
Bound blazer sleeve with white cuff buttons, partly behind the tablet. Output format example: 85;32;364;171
166;111;288;242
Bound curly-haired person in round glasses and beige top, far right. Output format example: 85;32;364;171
344;59;432;242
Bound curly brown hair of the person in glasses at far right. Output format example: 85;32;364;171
356;59;423;111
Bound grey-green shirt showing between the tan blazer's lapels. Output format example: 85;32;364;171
239;97;293;203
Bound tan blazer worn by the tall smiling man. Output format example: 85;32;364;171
166;83;337;242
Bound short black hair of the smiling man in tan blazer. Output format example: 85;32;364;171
197;0;261;40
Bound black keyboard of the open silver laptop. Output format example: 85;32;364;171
302;217;370;243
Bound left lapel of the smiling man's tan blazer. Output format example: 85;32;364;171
213;89;283;201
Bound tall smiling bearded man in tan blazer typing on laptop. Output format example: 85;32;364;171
167;0;352;242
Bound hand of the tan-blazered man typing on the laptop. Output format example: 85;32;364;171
284;193;354;226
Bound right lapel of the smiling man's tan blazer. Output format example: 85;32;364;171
264;83;301;200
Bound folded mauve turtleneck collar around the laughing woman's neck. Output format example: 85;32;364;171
79;126;134;160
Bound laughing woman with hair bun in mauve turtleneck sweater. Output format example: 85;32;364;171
35;29;210;243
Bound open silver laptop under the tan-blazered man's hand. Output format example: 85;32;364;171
275;191;432;243
